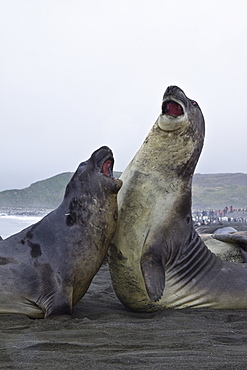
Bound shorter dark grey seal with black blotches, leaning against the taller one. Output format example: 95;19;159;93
0;147;122;318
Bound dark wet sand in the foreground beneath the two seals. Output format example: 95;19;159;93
0;265;247;370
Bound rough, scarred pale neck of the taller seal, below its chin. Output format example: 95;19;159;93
130;122;201;186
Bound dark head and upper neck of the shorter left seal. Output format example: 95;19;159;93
63;146;122;226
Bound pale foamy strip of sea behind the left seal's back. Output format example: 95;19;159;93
0;209;47;239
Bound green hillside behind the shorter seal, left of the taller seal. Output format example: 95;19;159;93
0;172;121;209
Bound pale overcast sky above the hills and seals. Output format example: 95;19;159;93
0;0;247;190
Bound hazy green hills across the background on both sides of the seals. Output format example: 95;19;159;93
0;172;247;209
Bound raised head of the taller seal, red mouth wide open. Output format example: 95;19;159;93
156;86;205;174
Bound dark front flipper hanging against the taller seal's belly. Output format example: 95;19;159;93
141;252;165;302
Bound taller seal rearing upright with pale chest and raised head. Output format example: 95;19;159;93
109;86;247;312
